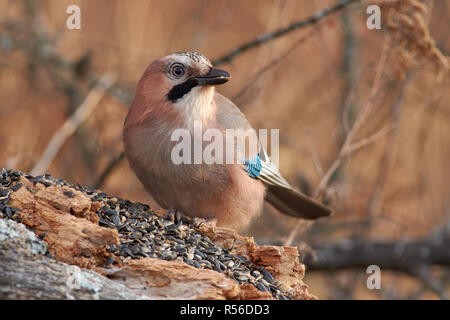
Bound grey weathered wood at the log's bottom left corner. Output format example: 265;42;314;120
0;219;146;300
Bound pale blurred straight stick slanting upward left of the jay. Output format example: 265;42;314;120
30;73;116;176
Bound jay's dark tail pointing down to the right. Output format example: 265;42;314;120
266;185;333;220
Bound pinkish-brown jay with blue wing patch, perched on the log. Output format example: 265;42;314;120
123;53;331;228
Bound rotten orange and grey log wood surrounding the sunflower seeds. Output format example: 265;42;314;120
0;172;316;299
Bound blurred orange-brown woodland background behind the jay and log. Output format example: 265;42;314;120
0;0;450;299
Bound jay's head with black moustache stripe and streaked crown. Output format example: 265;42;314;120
125;52;230;127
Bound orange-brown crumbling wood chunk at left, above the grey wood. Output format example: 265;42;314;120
9;177;119;271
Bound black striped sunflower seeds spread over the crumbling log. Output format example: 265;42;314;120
0;169;290;300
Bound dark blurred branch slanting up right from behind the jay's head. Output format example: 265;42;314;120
213;0;361;66
